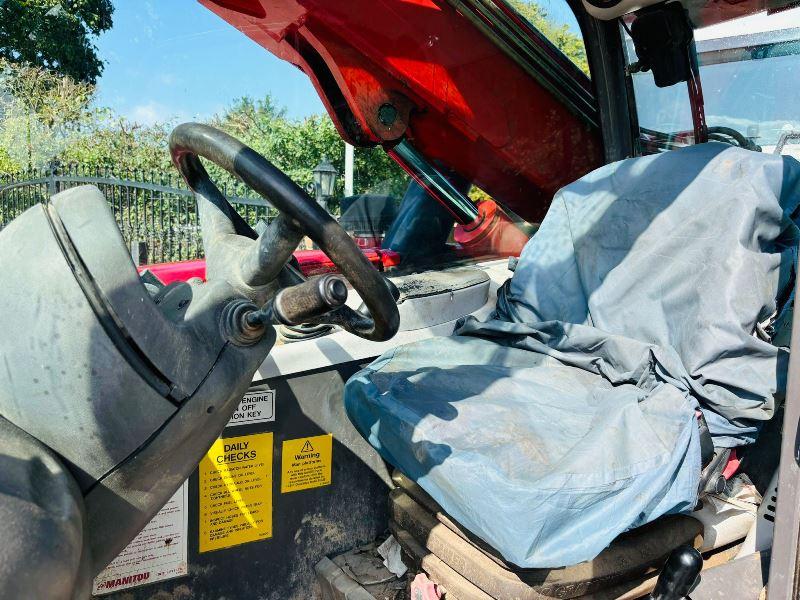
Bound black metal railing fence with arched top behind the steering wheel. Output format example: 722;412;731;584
0;165;277;263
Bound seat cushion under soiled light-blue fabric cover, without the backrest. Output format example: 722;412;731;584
345;336;700;568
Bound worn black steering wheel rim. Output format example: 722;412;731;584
169;123;400;341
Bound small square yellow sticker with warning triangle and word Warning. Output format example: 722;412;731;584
281;433;333;494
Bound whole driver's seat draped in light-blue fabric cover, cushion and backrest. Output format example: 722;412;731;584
345;143;800;597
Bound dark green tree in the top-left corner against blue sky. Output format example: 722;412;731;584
0;0;114;83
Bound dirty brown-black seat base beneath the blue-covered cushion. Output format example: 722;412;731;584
389;472;703;600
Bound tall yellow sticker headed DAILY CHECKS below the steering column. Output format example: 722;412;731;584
200;433;272;552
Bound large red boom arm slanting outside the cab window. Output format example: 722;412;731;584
200;0;603;221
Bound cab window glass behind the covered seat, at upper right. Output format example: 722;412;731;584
623;8;800;153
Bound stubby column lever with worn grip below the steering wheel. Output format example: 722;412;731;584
245;274;347;328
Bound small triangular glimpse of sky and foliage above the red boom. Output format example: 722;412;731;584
505;0;589;76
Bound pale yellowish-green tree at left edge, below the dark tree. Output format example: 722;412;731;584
0;59;96;169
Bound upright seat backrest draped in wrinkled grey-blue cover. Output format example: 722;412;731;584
498;143;800;446
